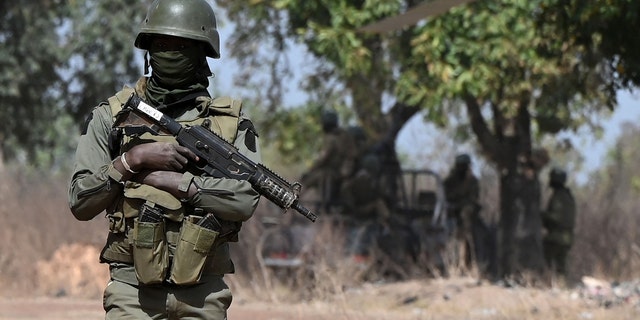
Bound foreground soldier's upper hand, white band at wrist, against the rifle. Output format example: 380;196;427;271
125;142;198;171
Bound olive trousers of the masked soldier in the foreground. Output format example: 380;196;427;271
103;268;232;320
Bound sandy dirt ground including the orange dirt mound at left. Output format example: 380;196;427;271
0;244;640;320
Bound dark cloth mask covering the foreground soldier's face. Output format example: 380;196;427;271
149;46;208;89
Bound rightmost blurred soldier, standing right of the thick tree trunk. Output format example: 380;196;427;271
542;168;576;275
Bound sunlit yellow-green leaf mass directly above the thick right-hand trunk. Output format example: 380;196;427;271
397;1;605;133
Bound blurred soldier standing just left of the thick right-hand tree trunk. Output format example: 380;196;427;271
444;154;480;268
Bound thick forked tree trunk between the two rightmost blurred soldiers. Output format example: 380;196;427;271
465;96;544;277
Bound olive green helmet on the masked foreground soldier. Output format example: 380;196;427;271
134;0;220;59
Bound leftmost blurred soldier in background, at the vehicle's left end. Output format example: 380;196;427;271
300;111;357;212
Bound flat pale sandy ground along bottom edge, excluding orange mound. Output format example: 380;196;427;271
0;279;640;320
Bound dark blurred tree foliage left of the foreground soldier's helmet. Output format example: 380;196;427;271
0;0;146;166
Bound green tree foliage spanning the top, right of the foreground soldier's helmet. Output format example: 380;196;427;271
219;0;615;165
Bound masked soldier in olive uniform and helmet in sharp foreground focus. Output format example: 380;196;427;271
69;0;261;320
